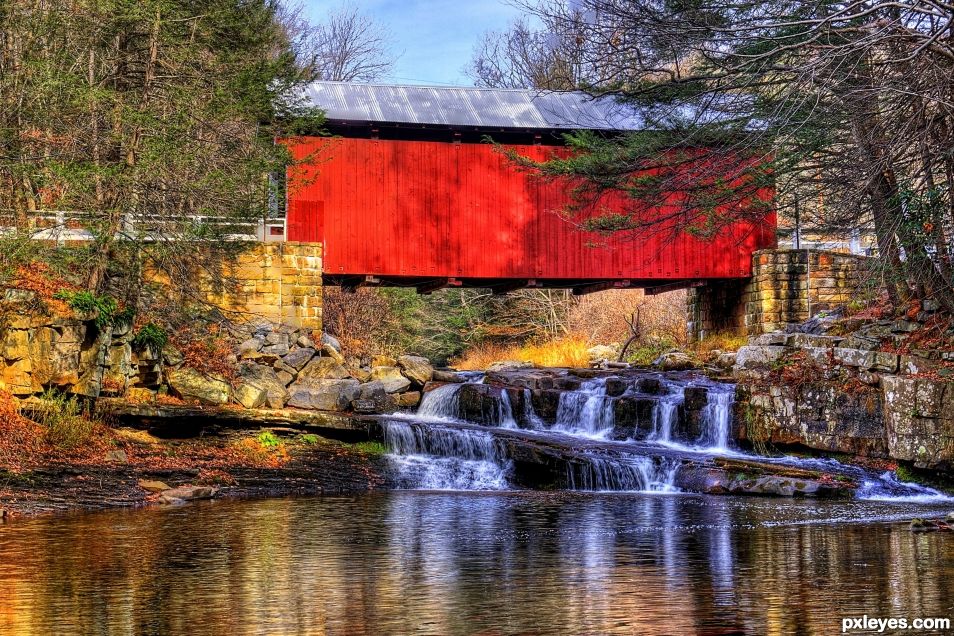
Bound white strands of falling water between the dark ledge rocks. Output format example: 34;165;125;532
384;375;954;503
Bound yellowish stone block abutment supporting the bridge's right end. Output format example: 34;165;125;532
688;249;880;340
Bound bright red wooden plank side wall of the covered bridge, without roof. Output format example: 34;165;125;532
288;138;775;281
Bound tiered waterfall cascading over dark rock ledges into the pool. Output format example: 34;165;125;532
383;374;948;501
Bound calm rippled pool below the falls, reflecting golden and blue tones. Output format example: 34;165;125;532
0;492;954;636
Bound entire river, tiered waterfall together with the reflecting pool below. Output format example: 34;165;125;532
0;374;954;636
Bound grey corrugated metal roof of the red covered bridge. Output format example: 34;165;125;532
306;82;643;130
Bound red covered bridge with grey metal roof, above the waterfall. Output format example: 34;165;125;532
286;82;775;293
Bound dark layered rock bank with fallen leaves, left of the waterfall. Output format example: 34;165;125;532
0;428;387;520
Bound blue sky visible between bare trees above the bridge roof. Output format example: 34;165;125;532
305;0;520;86
